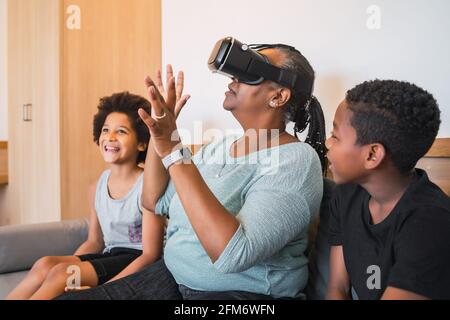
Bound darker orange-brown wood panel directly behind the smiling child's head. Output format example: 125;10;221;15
61;0;161;219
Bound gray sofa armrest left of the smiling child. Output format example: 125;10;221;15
0;219;88;274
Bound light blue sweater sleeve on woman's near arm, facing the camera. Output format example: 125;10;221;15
214;146;323;273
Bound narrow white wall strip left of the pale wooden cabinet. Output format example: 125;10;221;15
0;0;8;141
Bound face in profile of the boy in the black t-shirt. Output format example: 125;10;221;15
325;100;367;184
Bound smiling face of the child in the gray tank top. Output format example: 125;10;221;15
99;112;145;164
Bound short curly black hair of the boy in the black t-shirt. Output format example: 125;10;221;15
346;79;441;173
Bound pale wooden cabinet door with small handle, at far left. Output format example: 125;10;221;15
0;0;60;224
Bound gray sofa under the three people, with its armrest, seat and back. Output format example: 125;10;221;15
0;179;334;300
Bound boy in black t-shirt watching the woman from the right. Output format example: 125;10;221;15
326;80;450;299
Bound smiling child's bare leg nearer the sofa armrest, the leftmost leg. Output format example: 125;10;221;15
6;256;80;300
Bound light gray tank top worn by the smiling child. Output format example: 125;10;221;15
95;170;144;252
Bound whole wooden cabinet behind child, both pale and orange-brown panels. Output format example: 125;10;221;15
0;0;161;224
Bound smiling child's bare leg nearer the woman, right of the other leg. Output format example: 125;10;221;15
30;262;98;300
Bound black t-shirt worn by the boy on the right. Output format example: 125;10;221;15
329;169;450;299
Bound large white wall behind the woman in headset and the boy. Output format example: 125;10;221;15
162;0;450;143
